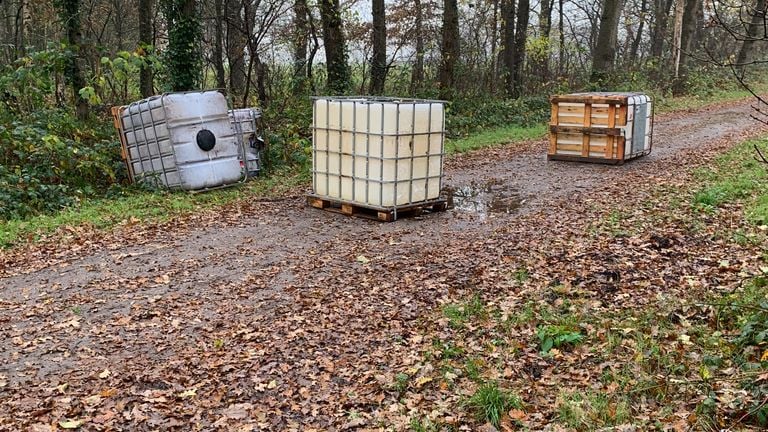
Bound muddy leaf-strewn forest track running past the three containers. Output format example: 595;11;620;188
0;98;760;430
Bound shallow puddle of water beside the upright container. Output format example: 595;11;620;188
443;179;525;220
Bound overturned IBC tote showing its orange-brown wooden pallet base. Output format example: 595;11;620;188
547;92;653;164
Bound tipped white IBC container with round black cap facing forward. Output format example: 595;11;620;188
120;91;243;190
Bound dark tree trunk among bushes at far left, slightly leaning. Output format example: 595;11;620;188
56;0;88;120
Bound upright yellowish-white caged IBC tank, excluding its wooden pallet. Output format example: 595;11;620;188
312;97;445;208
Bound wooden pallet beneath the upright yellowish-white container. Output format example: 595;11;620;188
307;194;448;222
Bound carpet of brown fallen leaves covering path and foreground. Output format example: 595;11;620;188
0;101;768;431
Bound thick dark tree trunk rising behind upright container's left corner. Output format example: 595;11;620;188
320;0;350;94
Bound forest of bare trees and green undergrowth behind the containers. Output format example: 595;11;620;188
0;0;768;219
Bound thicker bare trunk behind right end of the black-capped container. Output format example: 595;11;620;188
225;0;248;100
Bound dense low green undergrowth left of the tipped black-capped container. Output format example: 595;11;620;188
0;110;125;220
